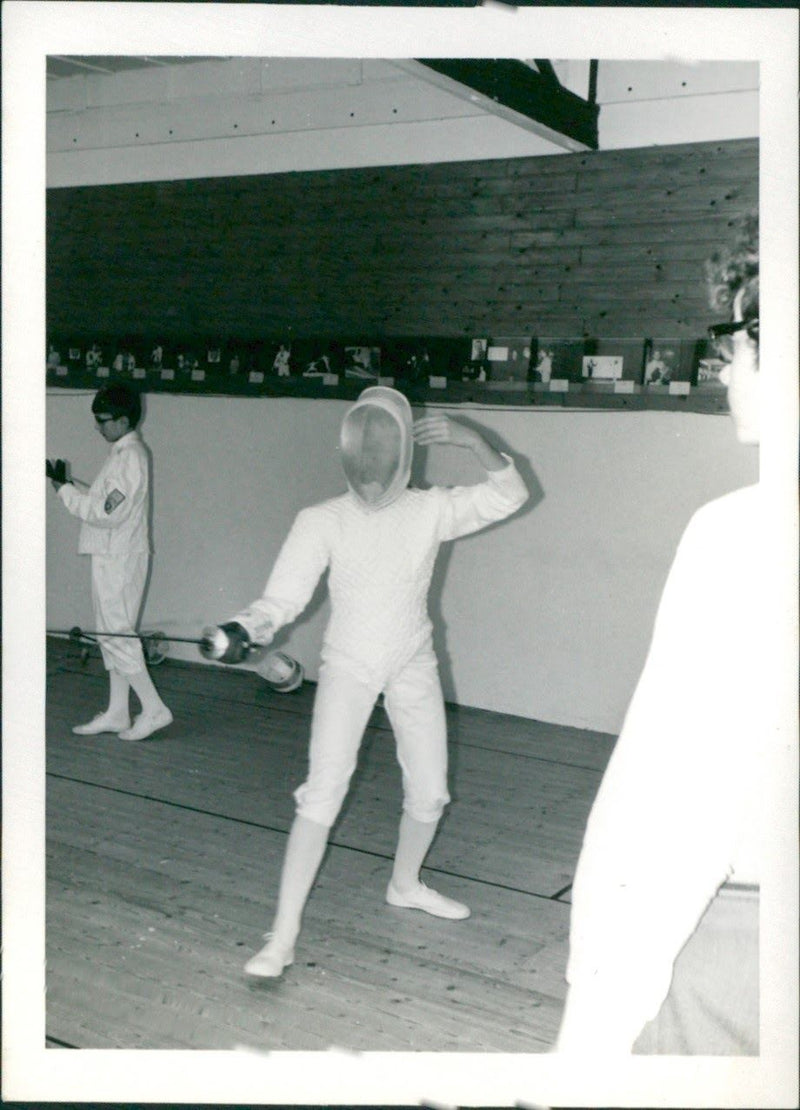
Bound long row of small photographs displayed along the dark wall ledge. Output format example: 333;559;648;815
47;335;722;403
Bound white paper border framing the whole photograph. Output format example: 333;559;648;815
2;0;798;1108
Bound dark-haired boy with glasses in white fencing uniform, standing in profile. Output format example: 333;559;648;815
53;385;172;740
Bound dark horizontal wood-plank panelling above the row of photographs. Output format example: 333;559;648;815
47;140;758;340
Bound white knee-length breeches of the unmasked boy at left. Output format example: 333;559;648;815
92;552;150;675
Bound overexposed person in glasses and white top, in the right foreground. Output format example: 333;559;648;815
556;214;774;1057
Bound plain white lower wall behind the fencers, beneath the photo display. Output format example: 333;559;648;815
47;391;757;733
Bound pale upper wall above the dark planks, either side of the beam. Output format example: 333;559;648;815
47;58;759;188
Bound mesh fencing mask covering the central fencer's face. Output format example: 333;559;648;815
340;385;414;509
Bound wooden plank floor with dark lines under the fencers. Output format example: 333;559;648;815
47;638;612;1052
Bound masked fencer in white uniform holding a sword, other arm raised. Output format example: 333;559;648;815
209;386;528;977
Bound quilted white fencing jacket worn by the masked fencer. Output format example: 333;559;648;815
234;390;528;692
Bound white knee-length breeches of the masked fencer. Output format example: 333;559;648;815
294;647;450;827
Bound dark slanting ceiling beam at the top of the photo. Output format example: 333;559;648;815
393;58;599;151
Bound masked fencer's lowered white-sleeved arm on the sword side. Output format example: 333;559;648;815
233;508;331;644
